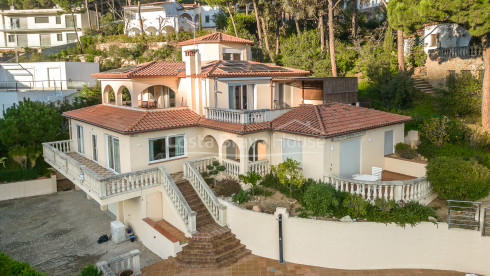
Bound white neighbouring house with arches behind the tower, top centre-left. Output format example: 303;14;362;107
124;0;220;36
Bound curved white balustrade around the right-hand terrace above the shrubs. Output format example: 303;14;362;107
324;175;432;202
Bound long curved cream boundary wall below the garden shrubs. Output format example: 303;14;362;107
222;201;490;275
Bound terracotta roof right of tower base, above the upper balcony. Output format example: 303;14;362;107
178;60;310;78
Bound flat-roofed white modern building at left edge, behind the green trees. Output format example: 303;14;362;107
0;61;99;117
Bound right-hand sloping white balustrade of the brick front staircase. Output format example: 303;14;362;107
184;161;226;226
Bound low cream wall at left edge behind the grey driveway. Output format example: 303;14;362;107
0;175;57;201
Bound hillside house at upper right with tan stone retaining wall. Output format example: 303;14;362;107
405;22;484;86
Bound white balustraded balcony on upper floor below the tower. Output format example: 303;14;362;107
205;107;291;124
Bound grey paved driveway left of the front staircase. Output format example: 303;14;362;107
0;190;161;275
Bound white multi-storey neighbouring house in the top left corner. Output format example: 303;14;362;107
0;8;96;49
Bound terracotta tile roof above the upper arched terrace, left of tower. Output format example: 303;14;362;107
92;60;185;79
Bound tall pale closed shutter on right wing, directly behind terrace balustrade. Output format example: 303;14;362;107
340;138;361;178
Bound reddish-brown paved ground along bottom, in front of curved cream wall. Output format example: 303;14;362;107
142;255;465;276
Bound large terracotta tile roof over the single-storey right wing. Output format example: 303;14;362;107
272;102;412;137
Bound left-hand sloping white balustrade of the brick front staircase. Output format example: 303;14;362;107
158;167;197;234
